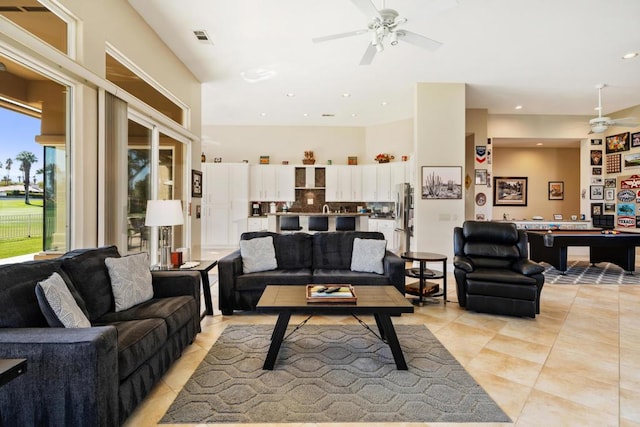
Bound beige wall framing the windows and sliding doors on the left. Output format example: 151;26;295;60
0;0;201;254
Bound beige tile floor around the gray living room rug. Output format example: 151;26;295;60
126;258;640;427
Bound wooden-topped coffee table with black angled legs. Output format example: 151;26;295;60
256;285;413;370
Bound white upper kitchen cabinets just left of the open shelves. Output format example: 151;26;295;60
249;165;296;202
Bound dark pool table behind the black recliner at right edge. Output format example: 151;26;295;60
527;229;640;273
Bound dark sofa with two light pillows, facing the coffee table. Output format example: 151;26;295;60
218;231;405;315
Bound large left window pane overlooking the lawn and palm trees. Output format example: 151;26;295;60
0;56;71;258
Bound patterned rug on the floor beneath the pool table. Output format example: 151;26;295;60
542;261;640;285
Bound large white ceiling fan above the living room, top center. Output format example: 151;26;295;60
311;0;442;65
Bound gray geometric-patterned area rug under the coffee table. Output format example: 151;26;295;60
161;325;510;423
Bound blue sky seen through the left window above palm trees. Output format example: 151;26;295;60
0;108;44;182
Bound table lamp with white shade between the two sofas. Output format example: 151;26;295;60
144;200;184;270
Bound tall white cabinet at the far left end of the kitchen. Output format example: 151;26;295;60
201;163;249;247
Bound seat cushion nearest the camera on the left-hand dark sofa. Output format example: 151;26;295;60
107;318;167;381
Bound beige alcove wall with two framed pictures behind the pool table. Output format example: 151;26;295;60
490;147;585;220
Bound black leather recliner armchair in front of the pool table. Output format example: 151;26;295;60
453;221;544;318
